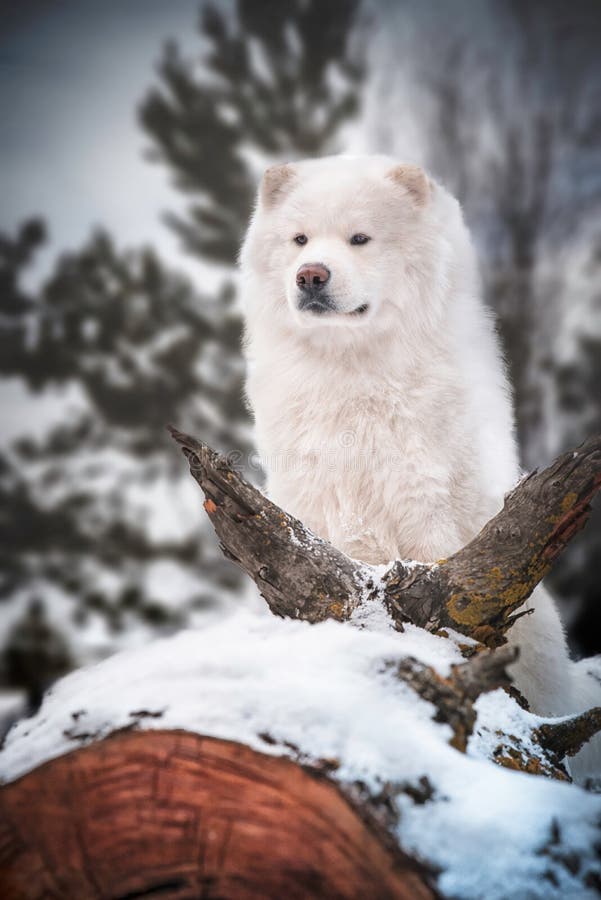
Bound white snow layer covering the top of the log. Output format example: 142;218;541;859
0;603;601;900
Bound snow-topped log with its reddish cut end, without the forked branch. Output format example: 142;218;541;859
0;610;601;900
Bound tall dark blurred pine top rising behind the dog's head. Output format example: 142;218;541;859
140;0;364;265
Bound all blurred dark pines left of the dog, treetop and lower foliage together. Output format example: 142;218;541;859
0;0;362;692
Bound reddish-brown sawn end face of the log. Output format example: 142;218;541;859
0;731;438;900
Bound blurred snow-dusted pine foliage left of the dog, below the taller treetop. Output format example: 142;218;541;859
0;222;246;684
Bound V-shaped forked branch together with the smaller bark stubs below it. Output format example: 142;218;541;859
169;426;601;780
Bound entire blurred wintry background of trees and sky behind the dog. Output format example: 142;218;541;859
0;0;601;705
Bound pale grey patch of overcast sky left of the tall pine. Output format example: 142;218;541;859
0;0;207;282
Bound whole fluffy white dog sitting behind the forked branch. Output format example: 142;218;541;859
241;156;601;775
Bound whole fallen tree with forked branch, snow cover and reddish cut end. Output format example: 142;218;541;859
0;429;601;900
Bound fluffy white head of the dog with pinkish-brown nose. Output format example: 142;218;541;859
241;157;462;338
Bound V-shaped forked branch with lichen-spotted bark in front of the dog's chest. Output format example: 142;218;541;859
170;427;601;647
